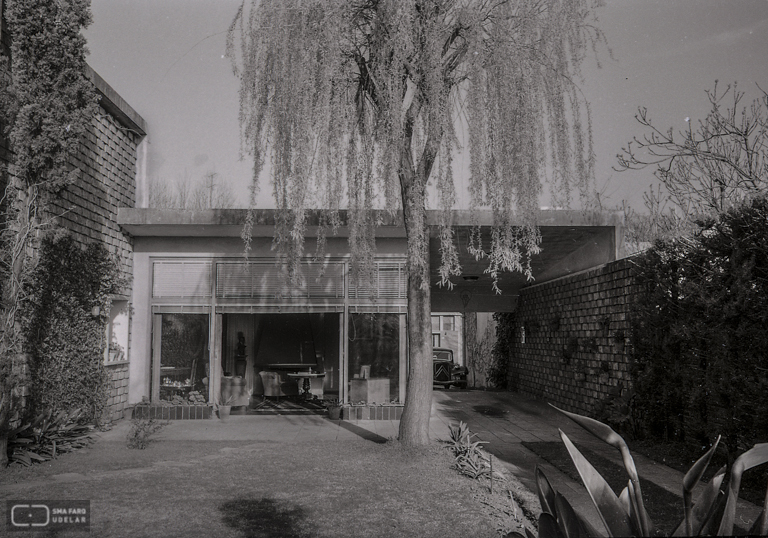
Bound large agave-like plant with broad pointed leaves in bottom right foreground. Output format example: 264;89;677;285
507;406;768;538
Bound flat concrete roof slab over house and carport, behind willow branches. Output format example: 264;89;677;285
117;208;621;312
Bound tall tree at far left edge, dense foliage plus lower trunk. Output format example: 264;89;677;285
0;0;97;428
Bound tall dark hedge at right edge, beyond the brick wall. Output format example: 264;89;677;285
632;198;768;459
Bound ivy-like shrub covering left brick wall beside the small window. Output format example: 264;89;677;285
23;231;121;421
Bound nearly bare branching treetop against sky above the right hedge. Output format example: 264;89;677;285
617;82;768;229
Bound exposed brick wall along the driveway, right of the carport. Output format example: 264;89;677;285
508;258;636;414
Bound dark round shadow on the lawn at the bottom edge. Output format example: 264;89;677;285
219;498;310;538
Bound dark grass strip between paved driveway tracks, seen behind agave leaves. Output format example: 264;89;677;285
523;442;683;534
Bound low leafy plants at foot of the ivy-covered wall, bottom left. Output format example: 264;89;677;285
8;409;93;466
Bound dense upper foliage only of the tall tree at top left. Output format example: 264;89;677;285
4;0;96;191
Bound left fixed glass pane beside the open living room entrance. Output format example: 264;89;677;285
160;314;209;404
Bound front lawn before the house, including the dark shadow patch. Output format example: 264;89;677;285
0;426;508;538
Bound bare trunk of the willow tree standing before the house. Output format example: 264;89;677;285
400;180;432;446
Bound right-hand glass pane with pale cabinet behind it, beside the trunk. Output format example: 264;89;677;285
347;313;400;403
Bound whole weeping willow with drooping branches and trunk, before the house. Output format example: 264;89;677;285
228;0;602;445
